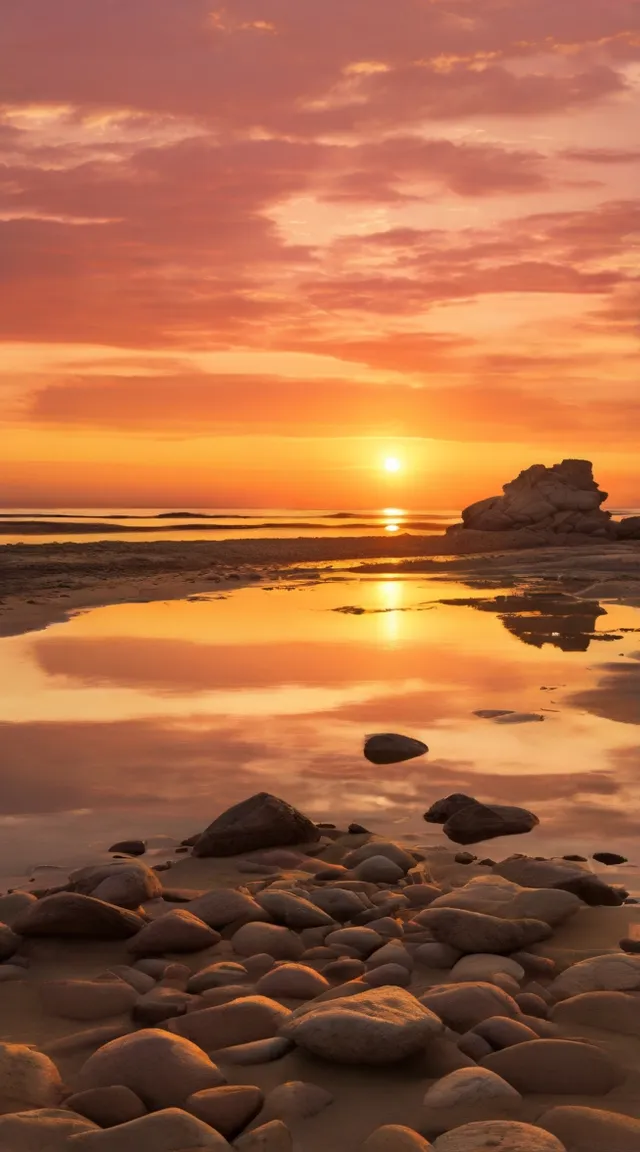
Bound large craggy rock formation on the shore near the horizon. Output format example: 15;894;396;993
448;460;618;547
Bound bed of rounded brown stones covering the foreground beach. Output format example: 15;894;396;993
0;792;640;1152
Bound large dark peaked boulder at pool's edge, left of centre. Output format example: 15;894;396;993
193;793;319;856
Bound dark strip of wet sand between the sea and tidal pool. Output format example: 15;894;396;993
0;535;640;636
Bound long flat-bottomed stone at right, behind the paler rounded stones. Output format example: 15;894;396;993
417;908;551;954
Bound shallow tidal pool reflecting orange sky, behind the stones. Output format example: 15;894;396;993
0;577;640;884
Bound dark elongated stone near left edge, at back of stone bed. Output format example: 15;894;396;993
14;892;145;940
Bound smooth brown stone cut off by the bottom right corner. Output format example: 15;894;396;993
539;1105;640;1152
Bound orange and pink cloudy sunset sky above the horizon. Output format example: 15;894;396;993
0;0;640;509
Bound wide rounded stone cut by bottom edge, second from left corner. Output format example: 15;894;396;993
69;1108;229;1152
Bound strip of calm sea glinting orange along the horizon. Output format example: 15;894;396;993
0;508;459;545
